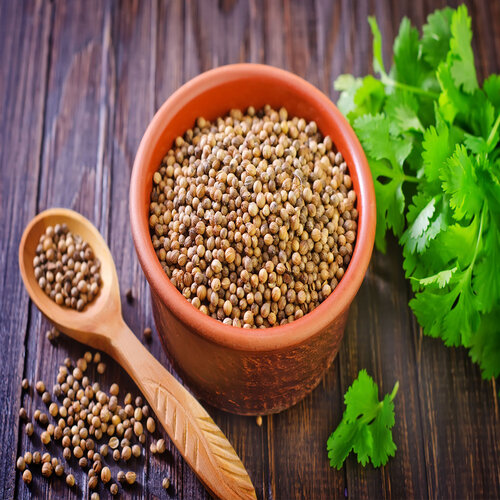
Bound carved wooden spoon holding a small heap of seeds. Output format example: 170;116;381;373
19;208;256;499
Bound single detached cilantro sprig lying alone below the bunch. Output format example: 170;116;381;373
327;370;399;470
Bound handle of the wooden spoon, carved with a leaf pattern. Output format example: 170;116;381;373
109;320;256;499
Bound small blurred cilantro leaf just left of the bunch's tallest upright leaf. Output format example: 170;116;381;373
422;7;453;68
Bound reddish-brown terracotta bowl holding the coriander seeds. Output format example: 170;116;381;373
130;64;375;415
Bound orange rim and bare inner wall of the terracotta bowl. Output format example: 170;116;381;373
130;64;375;351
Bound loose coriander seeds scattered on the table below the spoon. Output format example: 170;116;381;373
16;352;170;499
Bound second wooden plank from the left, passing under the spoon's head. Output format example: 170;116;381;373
17;1;111;498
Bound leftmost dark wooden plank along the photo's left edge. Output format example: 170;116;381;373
0;1;52;498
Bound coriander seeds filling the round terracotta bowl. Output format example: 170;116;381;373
149;106;358;328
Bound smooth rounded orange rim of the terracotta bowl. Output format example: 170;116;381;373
129;63;376;351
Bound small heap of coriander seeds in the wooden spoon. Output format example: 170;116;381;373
33;224;102;311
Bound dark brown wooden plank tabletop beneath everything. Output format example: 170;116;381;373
0;0;500;500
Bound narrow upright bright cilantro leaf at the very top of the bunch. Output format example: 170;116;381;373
450;5;478;93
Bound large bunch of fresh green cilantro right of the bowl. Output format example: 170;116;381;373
335;5;500;386
